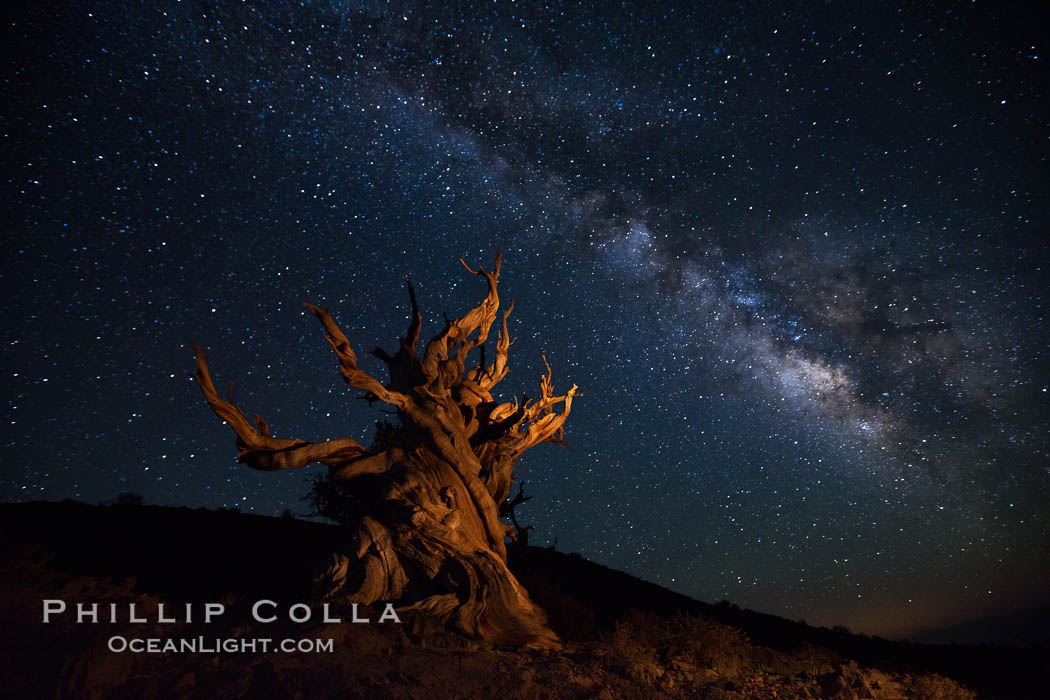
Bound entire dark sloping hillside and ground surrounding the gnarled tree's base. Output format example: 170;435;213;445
0;504;1047;700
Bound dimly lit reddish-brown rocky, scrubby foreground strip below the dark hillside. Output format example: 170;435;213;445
3;596;977;700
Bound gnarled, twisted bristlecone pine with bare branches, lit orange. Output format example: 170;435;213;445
193;255;578;649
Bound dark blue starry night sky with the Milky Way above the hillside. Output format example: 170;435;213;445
0;1;1050;636
